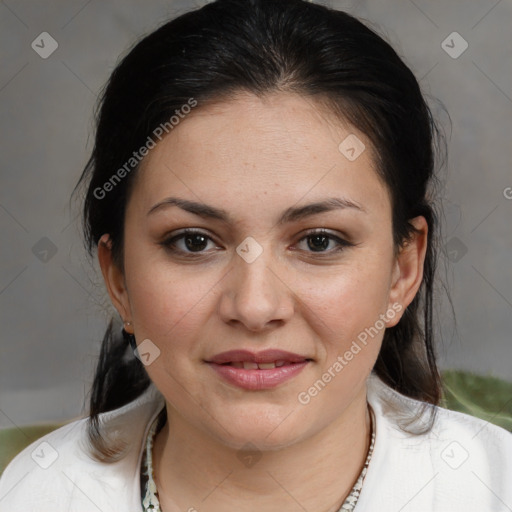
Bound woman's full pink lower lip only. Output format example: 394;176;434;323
208;361;308;391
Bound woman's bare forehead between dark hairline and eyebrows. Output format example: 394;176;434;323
130;93;389;221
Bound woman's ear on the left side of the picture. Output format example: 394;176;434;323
98;234;133;334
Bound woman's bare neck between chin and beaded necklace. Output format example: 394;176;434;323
153;388;371;512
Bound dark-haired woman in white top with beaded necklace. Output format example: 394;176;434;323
0;0;512;512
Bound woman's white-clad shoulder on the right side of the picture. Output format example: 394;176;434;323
363;376;512;512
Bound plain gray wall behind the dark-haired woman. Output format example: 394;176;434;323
0;0;512;428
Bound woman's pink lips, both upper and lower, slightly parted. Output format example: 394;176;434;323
206;349;311;391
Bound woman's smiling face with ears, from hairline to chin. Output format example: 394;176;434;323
100;93;425;449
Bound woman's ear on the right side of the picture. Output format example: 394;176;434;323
386;216;428;327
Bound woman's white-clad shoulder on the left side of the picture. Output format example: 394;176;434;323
0;385;165;512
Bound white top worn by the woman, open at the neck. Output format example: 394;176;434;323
0;376;512;512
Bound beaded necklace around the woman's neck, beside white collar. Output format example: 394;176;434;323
141;404;375;512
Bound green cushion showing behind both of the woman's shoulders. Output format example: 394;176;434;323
0;370;512;474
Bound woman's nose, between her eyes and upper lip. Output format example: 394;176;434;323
219;244;295;332
